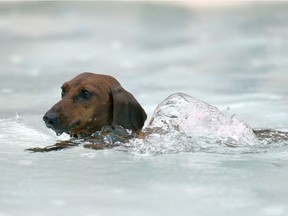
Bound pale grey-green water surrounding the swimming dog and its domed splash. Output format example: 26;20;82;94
0;2;288;216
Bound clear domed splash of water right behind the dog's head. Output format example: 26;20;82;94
128;93;258;155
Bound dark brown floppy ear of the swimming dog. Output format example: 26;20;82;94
111;86;147;131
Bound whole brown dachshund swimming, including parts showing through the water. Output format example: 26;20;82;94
27;72;288;152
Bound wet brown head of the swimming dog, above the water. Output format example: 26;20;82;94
29;73;147;151
